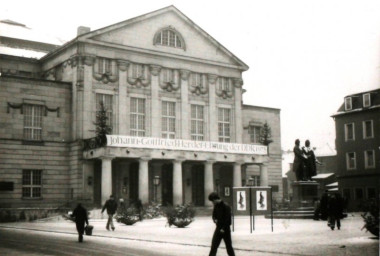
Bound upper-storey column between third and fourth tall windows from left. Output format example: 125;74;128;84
180;69;191;140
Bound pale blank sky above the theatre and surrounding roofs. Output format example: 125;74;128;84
0;0;380;153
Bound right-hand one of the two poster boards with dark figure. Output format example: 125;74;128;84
250;187;272;215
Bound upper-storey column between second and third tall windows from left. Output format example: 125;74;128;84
150;65;161;138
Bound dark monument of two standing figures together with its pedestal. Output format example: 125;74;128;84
291;139;320;208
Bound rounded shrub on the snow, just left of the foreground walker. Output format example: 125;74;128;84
165;204;195;228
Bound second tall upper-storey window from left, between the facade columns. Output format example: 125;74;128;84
130;98;145;137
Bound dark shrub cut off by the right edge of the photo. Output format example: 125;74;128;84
362;199;379;237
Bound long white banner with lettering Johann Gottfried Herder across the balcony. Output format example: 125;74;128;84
107;135;267;155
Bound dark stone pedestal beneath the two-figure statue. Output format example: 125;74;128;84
290;181;319;209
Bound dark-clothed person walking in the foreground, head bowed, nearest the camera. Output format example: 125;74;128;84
208;192;235;256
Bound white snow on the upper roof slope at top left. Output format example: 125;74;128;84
0;20;66;45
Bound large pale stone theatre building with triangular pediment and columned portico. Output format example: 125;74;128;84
0;6;282;208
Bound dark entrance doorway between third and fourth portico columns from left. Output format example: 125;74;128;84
191;164;205;206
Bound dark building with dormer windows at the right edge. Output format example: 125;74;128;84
332;89;380;210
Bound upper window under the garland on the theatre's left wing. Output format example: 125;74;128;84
24;104;44;140
